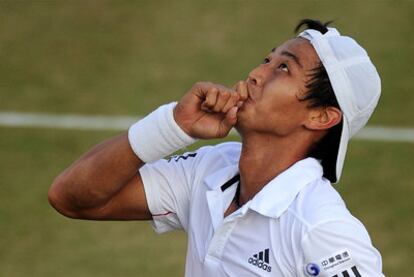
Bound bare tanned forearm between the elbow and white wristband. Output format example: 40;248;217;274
49;134;144;210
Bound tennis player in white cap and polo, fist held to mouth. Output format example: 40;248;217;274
49;19;383;277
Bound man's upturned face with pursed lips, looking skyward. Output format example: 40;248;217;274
237;38;320;136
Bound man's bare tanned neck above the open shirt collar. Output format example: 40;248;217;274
239;134;309;204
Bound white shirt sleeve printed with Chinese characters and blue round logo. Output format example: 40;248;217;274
302;221;384;277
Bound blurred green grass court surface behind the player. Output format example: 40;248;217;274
0;0;414;277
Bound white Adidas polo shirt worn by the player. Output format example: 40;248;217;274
140;142;384;277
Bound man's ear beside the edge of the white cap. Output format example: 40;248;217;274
305;106;342;130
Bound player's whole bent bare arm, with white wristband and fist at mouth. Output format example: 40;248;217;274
49;83;242;220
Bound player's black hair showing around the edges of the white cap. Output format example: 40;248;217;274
295;19;342;183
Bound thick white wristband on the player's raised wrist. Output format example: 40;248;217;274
128;102;196;163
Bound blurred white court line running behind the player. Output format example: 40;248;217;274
0;112;414;142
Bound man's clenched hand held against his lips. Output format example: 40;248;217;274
174;82;247;139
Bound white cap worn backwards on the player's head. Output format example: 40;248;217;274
298;28;381;183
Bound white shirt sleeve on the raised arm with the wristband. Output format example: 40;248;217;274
139;146;211;233
